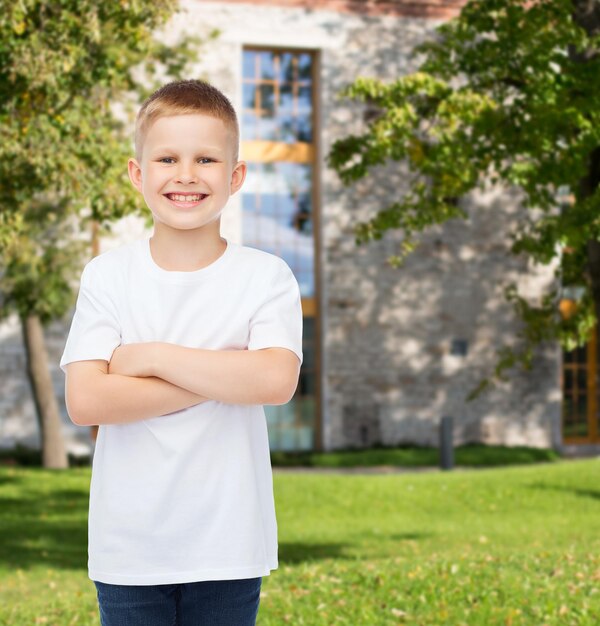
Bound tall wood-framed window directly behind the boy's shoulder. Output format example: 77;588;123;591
242;48;319;450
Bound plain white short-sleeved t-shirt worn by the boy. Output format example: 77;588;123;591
60;239;302;585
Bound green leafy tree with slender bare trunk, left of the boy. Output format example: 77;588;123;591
0;0;204;468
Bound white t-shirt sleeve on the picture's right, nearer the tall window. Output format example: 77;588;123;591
248;259;303;363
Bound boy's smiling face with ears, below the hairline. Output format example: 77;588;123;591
129;113;246;234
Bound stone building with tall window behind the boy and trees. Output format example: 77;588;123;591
0;0;598;450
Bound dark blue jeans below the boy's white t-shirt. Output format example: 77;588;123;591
94;577;262;626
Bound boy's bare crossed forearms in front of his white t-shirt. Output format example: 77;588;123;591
66;342;300;426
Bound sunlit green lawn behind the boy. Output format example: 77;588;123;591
0;460;600;626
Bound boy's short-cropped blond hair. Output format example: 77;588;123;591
135;80;240;161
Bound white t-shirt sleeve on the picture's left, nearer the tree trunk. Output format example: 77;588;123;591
60;263;121;371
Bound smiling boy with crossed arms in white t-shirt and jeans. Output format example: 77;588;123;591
61;81;302;626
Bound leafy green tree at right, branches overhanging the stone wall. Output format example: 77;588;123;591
329;0;600;397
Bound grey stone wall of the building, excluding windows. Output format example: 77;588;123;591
0;0;560;449
